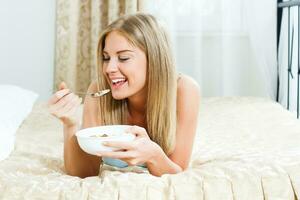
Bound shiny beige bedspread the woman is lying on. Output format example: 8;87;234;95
0;97;300;200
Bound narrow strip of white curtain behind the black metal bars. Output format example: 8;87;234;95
278;4;299;117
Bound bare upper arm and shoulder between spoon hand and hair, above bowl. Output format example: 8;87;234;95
82;82;99;128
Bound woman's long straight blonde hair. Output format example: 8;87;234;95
97;13;177;154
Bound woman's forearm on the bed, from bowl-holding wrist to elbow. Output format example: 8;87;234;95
147;146;183;176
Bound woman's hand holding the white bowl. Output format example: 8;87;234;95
97;126;161;166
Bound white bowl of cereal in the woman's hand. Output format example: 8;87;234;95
75;125;135;155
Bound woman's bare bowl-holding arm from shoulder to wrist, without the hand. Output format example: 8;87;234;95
147;76;200;176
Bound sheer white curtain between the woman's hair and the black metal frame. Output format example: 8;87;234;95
145;0;277;100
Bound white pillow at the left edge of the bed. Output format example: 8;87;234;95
0;84;38;161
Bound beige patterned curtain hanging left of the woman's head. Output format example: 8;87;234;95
54;0;143;95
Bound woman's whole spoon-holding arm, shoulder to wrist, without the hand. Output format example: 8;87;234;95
64;83;101;178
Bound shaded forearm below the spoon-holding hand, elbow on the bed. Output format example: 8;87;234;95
64;126;100;178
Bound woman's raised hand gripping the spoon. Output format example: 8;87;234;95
48;82;82;127
